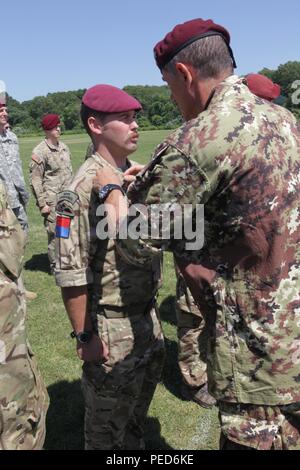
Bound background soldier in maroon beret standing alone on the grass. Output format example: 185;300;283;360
29;114;72;273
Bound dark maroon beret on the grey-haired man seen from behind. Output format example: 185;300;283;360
154;18;236;69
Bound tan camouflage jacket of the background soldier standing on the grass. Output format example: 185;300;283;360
29;140;72;211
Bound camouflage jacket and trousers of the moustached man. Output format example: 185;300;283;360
55;154;164;450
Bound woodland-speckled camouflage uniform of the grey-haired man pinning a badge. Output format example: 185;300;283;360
118;76;300;449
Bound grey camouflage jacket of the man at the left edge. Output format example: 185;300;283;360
0;130;29;209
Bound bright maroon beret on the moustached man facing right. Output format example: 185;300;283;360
82;85;142;113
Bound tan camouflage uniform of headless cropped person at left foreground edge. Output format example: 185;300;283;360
0;183;48;450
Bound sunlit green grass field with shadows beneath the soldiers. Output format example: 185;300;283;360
20;131;219;450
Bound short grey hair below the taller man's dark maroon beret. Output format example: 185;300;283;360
164;36;233;79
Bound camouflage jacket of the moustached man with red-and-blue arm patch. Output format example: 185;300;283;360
55;154;160;307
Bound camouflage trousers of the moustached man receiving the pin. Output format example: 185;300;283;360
82;308;164;450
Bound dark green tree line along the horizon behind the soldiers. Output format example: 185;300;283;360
8;61;300;135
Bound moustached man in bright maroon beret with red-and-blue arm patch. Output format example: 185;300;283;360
55;85;164;450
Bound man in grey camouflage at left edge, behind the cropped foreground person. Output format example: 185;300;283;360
0;100;37;300
